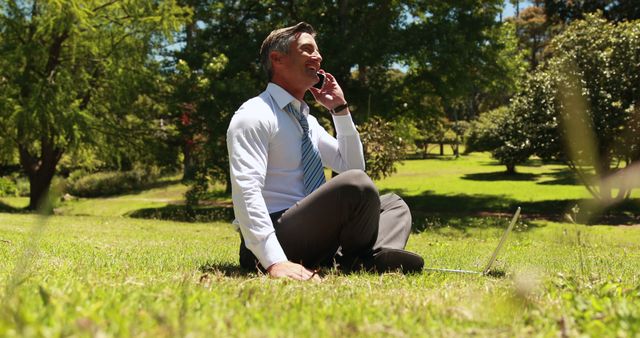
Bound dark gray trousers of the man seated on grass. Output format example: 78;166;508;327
240;170;411;269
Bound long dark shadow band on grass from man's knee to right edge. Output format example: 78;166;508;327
380;190;640;231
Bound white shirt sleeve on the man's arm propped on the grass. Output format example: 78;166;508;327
227;107;287;268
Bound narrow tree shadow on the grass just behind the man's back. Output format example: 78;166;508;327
126;205;234;222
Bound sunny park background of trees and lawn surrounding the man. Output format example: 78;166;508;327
0;0;640;336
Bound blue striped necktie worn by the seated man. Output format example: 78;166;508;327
285;103;325;195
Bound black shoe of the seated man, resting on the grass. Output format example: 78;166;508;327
364;248;424;273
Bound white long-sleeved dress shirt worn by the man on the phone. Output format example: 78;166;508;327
227;83;364;268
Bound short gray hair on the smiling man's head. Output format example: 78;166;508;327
260;22;316;81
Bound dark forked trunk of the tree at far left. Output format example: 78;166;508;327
18;142;63;210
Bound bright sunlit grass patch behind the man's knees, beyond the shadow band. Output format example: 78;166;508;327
378;153;590;201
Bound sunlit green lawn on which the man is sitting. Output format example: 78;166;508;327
0;155;640;337
